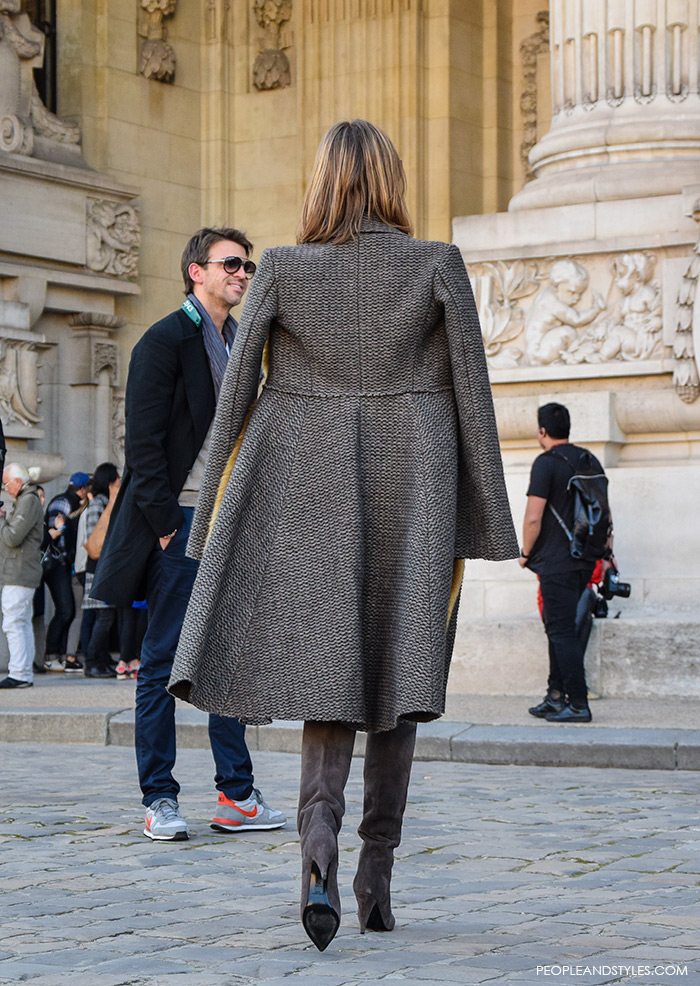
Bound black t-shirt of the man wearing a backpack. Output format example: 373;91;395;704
527;442;603;575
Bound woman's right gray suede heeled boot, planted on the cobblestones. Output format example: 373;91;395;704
353;722;416;934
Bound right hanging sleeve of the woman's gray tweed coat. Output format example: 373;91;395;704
434;244;519;561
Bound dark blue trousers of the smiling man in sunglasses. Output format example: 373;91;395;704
136;508;253;807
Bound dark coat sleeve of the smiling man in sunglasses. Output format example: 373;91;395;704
124;329;184;537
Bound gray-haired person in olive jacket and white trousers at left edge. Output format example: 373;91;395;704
0;462;44;688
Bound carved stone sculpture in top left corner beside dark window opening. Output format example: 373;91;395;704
0;0;80;155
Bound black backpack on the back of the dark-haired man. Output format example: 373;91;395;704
548;448;611;562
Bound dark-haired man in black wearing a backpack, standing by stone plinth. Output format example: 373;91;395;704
519;403;612;722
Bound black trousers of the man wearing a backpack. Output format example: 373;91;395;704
540;565;593;706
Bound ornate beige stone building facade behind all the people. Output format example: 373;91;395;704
0;0;700;694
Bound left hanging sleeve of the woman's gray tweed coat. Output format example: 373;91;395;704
187;250;277;558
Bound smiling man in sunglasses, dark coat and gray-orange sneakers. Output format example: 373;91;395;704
91;228;286;841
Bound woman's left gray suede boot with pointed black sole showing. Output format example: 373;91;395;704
297;722;355;952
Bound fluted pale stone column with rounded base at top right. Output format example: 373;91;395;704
510;0;700;210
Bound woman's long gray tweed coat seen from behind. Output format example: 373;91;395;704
170;220;519;730
